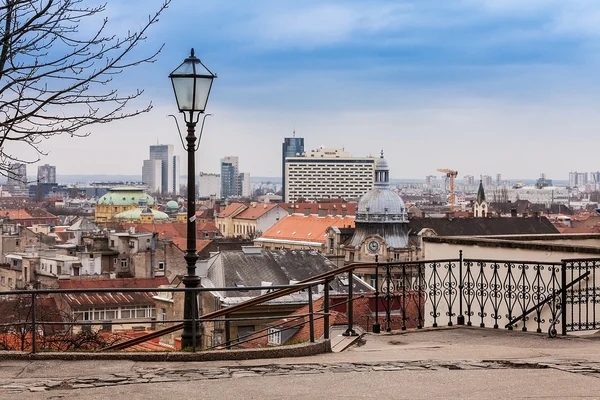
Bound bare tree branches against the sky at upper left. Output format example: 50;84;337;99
0;0;171;176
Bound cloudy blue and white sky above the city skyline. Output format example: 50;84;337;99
17;0;600;179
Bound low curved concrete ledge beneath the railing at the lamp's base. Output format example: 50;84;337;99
0;340;331;361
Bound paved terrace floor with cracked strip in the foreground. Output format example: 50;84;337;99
0;328;600;400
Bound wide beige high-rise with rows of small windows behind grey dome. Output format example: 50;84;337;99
284;148;377;202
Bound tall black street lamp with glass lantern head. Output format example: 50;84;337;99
169;49;217;348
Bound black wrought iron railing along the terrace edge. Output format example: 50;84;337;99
0;252;600;353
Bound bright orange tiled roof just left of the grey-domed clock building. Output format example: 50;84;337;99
261;214;354;243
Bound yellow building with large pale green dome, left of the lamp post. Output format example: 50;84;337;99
94;186;156;223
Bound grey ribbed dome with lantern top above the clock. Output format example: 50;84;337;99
356;151;408;223
